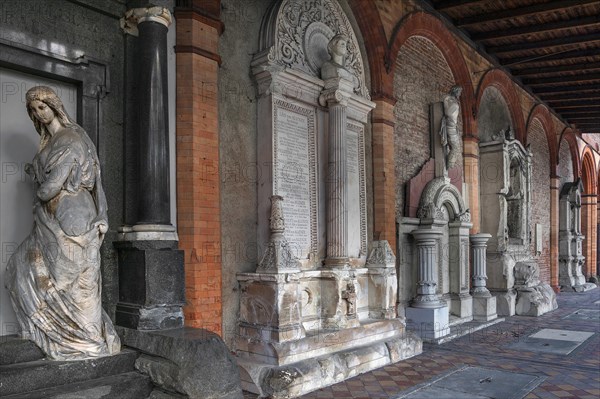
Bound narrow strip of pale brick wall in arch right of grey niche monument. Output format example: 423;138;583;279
527;119;550;283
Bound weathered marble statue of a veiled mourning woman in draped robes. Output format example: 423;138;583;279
6;86;120;360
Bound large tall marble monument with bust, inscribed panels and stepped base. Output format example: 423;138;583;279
237;0;421;397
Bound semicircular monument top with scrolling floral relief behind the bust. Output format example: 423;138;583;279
259;0;370;100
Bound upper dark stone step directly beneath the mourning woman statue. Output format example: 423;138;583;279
0;349;138;398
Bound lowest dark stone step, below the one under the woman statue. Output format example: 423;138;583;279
2;371;154;399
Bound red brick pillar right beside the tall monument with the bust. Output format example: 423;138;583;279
371;98;396;252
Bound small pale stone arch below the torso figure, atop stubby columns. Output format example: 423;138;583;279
417;177;471;222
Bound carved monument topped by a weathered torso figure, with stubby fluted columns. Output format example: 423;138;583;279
399;86;496;341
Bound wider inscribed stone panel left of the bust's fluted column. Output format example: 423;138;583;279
273;100;317;259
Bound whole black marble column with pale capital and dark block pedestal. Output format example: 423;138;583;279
114;7;185;330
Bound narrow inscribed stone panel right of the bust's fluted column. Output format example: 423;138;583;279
346;124;367;258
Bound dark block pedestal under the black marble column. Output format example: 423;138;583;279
114;241;185;330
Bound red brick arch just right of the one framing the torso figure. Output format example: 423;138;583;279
475;69;526;144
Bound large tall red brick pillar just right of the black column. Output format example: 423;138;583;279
175;1;223;334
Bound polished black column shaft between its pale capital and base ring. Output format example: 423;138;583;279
137;20;171;225
